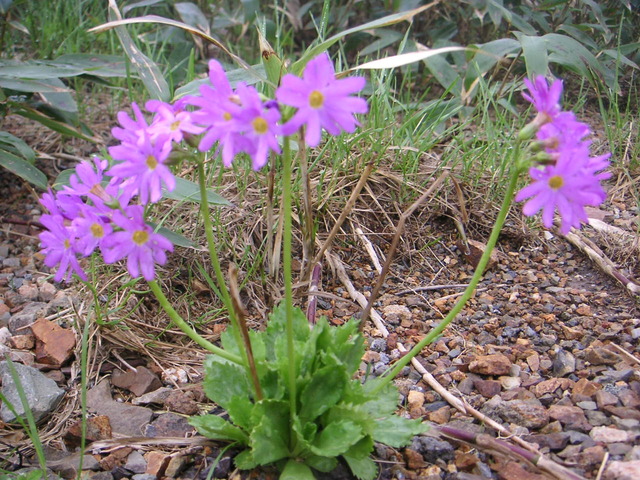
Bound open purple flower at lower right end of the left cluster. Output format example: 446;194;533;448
102;205;173;281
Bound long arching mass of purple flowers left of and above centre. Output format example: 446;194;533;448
40;54;367;281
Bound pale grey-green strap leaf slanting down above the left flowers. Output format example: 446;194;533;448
105;0;171;102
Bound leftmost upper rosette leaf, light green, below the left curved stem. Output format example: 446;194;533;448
203;355;251;410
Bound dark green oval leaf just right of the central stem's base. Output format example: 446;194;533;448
299;361;349;422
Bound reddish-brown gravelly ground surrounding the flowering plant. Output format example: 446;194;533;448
0;113;640;480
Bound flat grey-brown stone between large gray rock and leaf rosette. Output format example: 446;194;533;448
87;380;153;437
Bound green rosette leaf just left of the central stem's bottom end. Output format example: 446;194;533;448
250;400;291;465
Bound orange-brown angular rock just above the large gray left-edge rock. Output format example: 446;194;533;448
31;318;76;368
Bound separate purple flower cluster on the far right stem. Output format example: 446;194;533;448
516;76;610;234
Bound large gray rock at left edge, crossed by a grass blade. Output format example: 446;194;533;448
0;362;64;423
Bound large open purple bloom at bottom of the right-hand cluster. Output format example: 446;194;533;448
515;148;609;234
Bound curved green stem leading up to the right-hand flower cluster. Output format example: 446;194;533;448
372;149;523;394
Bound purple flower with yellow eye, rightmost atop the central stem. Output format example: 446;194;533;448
276;54;367;147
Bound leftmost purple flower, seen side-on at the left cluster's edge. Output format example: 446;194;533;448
40;214;87;282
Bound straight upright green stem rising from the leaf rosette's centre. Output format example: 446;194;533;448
282;137;297;420
